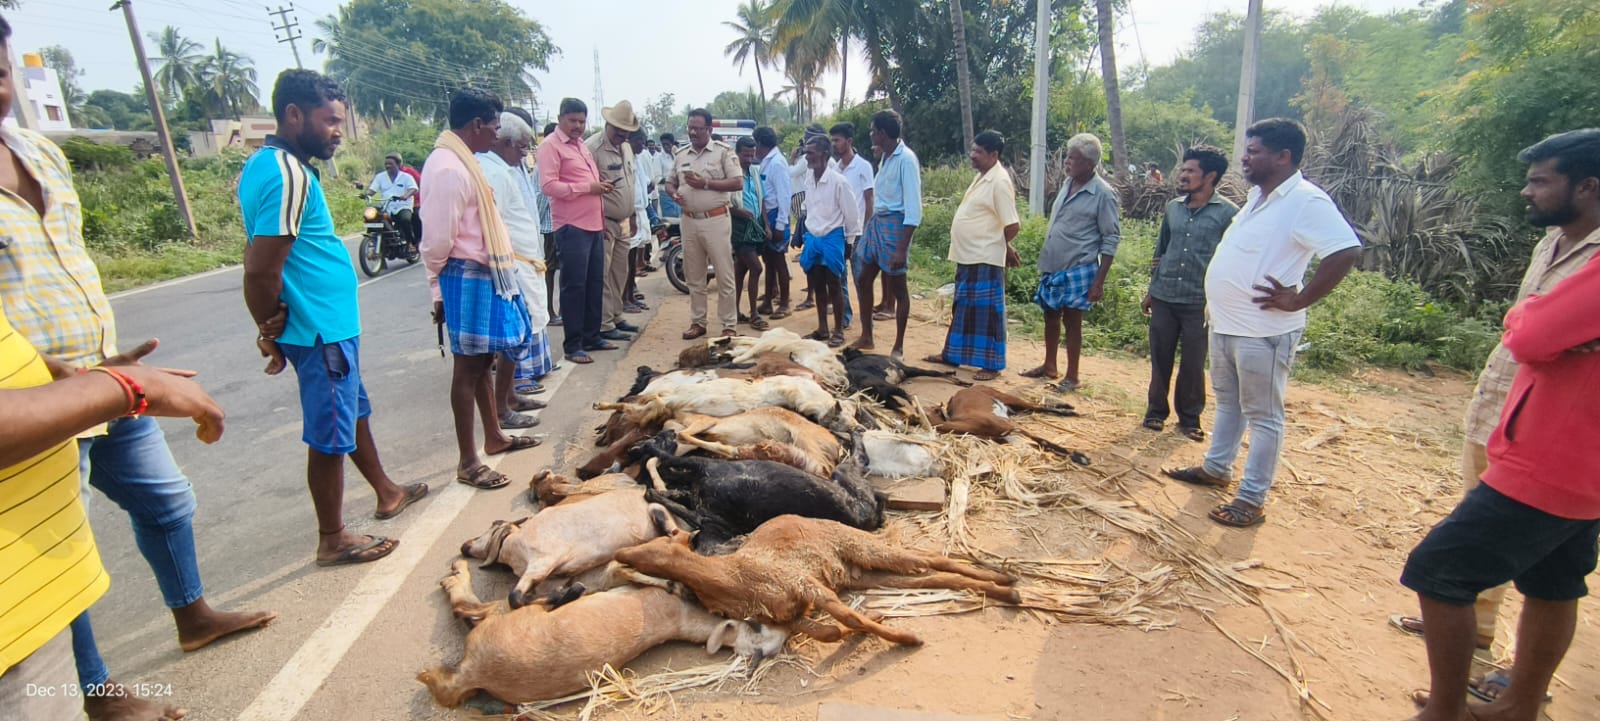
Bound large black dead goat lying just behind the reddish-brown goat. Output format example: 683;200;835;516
629;430;886;550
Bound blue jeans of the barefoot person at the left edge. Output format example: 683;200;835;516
72;416;205;684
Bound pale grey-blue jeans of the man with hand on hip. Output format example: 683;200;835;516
1203;331;1304;507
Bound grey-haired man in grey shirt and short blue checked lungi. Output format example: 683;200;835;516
1022;133;1122;392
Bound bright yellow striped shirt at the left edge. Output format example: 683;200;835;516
0;309;110;673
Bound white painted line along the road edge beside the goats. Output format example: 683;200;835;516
238;364;571;721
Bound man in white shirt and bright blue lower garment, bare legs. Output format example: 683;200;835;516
800;136;861;349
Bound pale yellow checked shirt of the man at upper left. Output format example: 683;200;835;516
0;128;117;366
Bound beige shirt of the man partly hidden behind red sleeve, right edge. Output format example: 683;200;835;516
1466;229;1600;446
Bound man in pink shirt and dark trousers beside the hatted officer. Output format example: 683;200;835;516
538;98;616;364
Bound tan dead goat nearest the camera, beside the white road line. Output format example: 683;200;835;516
416;561;787;708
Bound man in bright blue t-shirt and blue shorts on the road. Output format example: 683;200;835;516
238;70;427;566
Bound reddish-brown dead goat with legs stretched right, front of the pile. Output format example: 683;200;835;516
616;516;1021;646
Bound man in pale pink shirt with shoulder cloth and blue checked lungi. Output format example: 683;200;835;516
421;88;539;488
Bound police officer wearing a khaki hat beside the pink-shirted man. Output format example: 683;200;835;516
586;101;638;341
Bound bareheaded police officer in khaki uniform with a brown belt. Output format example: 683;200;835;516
667;107;744;341
